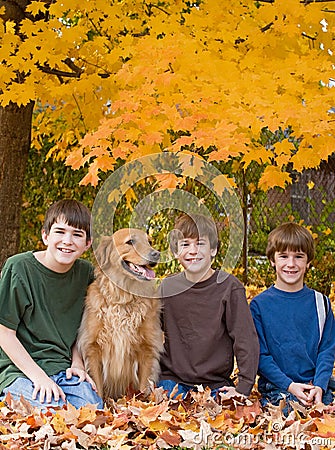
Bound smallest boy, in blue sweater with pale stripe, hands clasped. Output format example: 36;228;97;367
250;223;335;406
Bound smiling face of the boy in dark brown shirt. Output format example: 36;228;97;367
174;236;217;283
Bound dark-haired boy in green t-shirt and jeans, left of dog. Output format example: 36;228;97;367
0;199;103;408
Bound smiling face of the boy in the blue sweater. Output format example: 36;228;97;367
271;250;309;292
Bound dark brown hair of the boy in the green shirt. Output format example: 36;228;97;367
43;199;91;242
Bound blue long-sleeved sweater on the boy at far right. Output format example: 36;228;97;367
250;286;335;391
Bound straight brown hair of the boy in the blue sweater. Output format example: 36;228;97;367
266;222;315;262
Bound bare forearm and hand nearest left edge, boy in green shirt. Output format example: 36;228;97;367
0;324;65;403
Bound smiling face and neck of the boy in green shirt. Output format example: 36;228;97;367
42;219;91;273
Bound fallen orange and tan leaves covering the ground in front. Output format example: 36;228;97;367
0;387;335;450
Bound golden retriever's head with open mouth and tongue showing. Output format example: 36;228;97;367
96;228;160;280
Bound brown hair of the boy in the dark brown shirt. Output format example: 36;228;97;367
169;213;219;254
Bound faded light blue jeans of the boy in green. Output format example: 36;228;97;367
0;372;103;409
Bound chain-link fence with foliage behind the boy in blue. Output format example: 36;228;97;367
239;154;335;294
